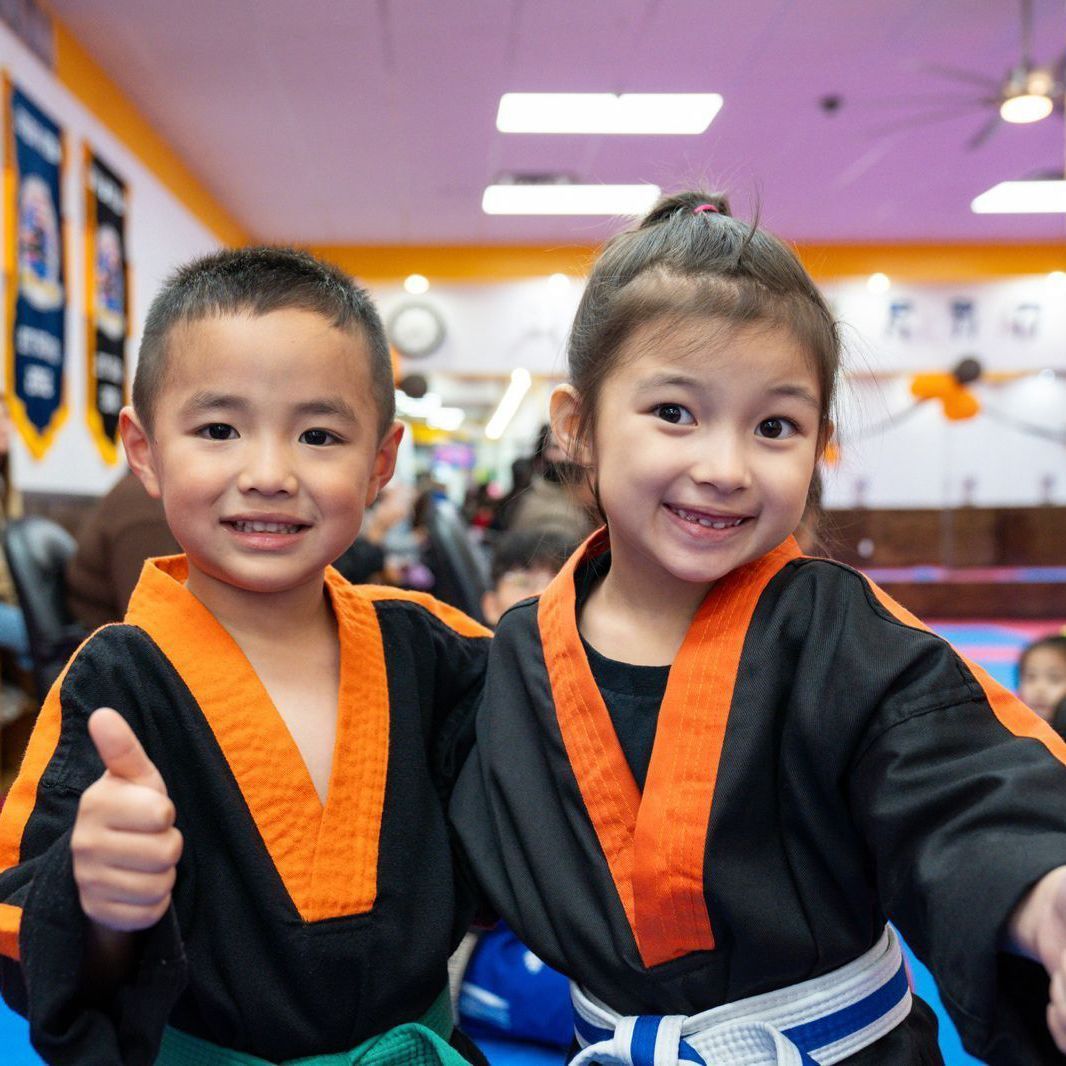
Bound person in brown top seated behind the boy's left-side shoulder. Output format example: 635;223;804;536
66;471;181;630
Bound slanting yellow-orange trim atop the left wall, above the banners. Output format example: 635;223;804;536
51;15;248;245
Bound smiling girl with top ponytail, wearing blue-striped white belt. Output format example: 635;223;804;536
452;193;1066;1066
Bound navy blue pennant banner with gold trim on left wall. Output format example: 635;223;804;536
4;79;66;459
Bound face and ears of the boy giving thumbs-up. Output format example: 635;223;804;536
122;309;402;605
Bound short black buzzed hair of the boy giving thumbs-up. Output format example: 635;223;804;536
133;245;395;436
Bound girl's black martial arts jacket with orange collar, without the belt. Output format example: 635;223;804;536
451;535;1066;1064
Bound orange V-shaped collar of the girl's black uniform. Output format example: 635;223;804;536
537;530;801;967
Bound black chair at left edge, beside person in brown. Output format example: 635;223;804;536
3;516;87;702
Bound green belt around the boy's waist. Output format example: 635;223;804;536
156;988;468;1066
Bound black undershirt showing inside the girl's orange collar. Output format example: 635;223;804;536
575;553;669;792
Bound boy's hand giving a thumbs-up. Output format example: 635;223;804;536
70;708;182;932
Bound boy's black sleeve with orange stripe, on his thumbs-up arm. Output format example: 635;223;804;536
0;627;185;1066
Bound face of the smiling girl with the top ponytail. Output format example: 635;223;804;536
556;319;822;601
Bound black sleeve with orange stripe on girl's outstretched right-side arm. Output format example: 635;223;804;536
847;588;1066;1064
